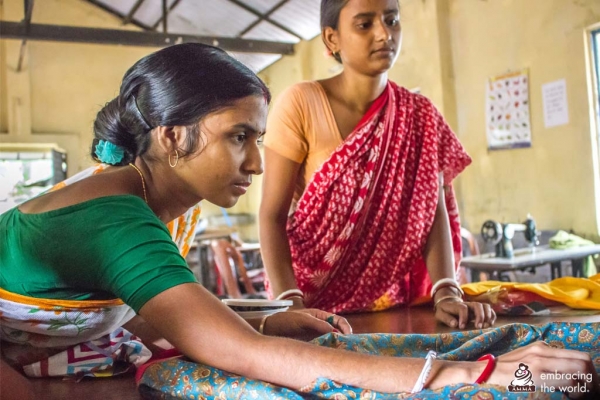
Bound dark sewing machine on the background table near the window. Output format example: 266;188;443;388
481;215;539;258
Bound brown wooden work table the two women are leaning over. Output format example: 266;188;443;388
25;306;600;400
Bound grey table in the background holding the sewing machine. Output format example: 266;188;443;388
460;244;600;280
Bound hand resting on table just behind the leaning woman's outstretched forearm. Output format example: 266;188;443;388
263;308;352;340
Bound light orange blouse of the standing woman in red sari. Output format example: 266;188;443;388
264;81;344;206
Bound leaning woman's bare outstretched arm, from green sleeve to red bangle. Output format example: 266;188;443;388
140;284;479;392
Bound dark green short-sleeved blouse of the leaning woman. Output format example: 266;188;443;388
0;195;196;312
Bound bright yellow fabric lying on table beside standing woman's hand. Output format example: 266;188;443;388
461;274;600;310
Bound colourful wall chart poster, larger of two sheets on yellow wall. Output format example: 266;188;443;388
486;69;531;150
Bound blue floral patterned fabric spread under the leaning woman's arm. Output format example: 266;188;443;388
139;323;600;400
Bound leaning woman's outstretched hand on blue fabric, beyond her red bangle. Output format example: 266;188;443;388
482;342;600;399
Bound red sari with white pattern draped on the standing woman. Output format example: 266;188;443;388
287;82;471;312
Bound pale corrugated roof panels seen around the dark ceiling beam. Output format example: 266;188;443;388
87;0;320;72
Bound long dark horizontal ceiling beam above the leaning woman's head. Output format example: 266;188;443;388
0;21;294;55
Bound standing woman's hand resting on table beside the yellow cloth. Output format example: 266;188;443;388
434;289;496;329
